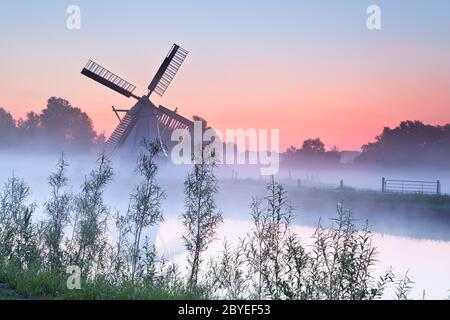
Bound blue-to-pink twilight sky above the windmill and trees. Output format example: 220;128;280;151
0;0;450;150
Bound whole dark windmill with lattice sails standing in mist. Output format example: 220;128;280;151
81;44;193;155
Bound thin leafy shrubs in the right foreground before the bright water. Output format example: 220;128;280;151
208;179;412;300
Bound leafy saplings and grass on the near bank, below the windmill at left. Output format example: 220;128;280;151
0;152;195;299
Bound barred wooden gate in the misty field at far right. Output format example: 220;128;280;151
381;177;441;195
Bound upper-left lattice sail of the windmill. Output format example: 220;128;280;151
81;60;137;98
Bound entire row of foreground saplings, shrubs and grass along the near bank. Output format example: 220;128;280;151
0;143;412;300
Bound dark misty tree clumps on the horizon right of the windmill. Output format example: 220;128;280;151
282;121;450;168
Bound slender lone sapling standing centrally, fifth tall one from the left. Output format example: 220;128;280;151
182;154;223;291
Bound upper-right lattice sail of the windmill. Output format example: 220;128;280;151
148;44;189;97
